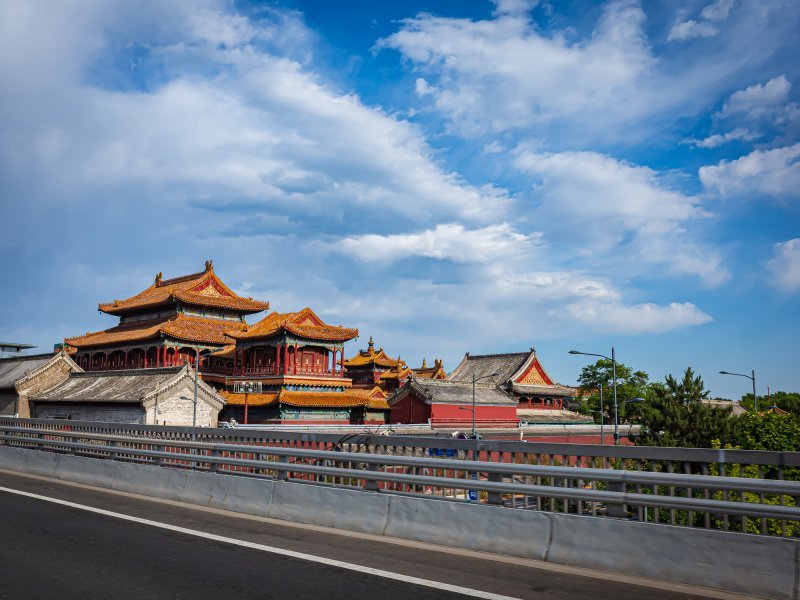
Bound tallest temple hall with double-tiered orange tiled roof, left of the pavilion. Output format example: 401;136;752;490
64;261;269;371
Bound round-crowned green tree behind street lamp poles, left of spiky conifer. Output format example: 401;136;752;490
576;358;649;423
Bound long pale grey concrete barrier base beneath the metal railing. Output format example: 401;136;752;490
0;446;800;600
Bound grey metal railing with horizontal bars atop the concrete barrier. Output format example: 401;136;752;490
0;418;800;537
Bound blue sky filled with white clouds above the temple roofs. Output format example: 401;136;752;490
0;0;800;398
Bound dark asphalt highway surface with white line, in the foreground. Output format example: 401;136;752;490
0;471;744;600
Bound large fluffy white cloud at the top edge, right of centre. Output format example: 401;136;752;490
377;1;653;136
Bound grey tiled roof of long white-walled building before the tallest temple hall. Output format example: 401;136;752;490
31;367;183;403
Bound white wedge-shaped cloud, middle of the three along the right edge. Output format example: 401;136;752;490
699;143;800;200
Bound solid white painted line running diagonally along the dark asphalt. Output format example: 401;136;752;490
0;486;520;600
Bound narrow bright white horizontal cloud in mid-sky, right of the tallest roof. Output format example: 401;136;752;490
332;223;539;263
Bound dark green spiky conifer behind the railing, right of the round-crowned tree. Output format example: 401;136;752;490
635;367;733;448
